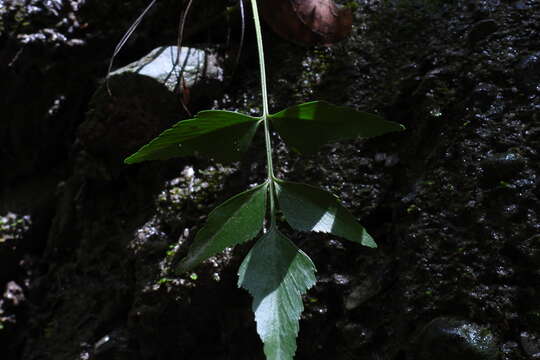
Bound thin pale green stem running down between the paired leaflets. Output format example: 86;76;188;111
251;0;276;226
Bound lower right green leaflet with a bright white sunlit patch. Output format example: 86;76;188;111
276;180;377;248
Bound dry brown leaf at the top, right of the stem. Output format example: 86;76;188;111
262;0;352;45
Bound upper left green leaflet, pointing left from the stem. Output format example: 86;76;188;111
124;110;261;164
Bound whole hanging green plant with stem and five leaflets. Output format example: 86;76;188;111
125;0;403;360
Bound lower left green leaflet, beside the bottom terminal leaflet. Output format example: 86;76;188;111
178;182;268;273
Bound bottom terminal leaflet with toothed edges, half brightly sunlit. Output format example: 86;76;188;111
238;227;316;360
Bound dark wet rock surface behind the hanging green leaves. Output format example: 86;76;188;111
0;0;540;360
